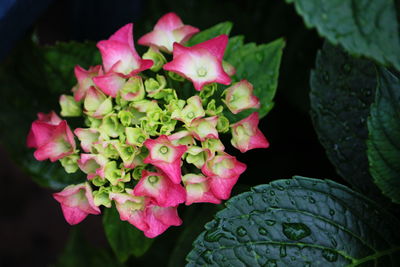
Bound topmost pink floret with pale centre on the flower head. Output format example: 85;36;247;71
138;12;199;53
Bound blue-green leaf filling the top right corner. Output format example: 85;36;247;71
287;0;400;70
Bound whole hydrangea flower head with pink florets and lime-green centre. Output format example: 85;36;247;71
27;13;268;238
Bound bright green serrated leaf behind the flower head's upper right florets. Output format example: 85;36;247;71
224;36;285;122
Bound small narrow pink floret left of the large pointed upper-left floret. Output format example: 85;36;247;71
72;65;103;101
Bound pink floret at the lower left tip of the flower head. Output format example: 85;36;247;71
53;183;100;225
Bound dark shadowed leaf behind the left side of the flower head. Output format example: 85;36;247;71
0;41;99;190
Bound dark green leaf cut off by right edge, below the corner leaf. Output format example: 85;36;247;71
367;68;400;204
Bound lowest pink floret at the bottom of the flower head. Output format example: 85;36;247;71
110;193;182;238
